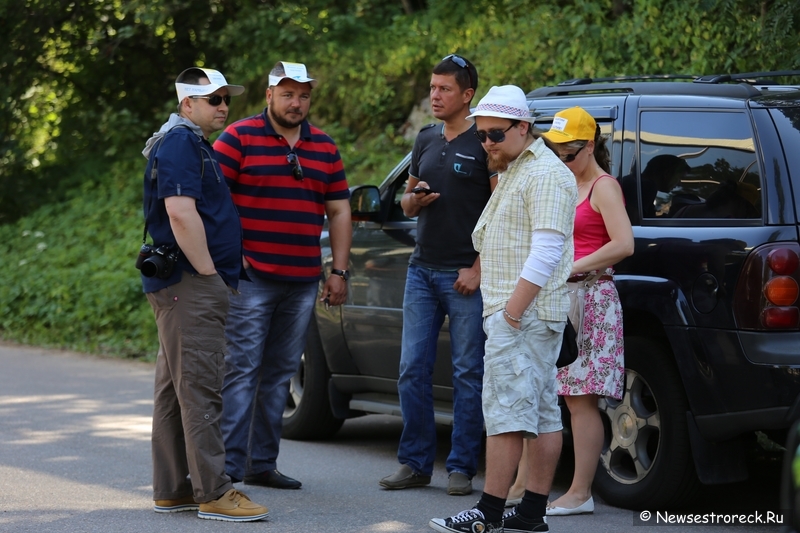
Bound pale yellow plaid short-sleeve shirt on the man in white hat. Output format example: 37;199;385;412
472;139;578;321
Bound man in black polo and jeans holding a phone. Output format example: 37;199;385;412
380;55;497;495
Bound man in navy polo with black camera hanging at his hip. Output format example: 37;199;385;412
137;68;268;522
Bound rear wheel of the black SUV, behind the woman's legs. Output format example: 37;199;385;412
594;337;699;511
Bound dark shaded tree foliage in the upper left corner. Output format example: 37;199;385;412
0;0;242;223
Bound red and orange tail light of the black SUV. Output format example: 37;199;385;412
734;243;800;330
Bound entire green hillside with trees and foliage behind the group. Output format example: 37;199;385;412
0;0;800;355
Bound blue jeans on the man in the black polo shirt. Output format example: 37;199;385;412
397;265;486;478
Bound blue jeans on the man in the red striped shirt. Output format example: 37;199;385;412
220;270;319;480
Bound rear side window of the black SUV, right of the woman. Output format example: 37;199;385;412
639;110;761;219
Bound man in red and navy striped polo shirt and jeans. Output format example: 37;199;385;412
214;61;352;489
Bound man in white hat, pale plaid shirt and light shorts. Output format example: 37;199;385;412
429;85;577;533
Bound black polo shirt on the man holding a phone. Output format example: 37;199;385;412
409;124;494;270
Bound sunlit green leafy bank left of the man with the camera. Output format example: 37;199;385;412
0;156;158;356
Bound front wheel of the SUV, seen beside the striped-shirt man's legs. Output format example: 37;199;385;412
282;318;344;440
